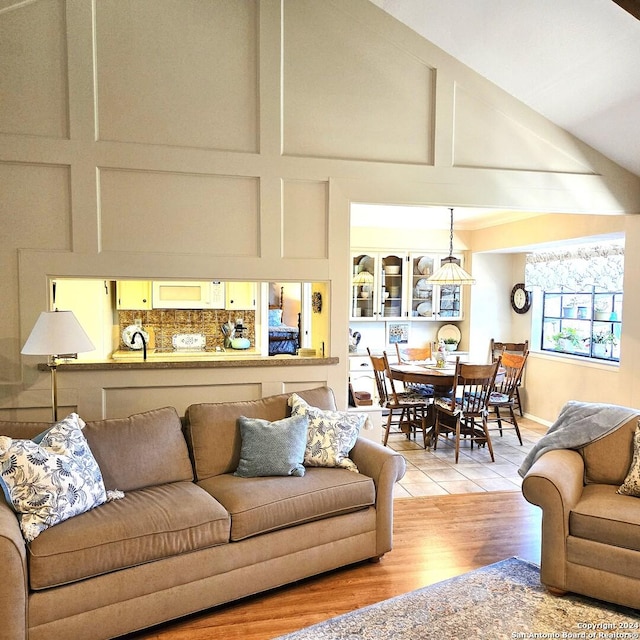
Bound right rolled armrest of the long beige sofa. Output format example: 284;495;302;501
349;438;407;556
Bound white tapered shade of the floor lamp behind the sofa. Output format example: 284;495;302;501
20;311;95;356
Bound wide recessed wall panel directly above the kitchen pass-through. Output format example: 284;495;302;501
100;169;259;257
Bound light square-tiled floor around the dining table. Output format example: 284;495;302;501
388;418;547;498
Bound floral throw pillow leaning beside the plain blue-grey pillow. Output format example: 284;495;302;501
289;393;367;473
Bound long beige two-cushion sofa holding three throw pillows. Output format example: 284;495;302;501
0;388;405;640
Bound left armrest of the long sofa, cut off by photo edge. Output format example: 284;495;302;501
0;496;28;640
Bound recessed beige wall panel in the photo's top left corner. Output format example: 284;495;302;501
0;0;69;138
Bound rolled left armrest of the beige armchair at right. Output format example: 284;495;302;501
522;449;584;589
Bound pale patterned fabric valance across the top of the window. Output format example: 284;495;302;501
525;243;624;292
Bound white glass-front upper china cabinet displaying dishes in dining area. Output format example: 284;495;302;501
351;251;462;321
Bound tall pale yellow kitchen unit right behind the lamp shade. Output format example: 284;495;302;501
50;278;117;360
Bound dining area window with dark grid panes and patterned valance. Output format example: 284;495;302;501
525;241;624;362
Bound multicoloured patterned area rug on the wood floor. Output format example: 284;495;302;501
279;558;640;640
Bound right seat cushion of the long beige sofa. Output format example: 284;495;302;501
198;468;375;541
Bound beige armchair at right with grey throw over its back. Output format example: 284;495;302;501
522;416;640;609
